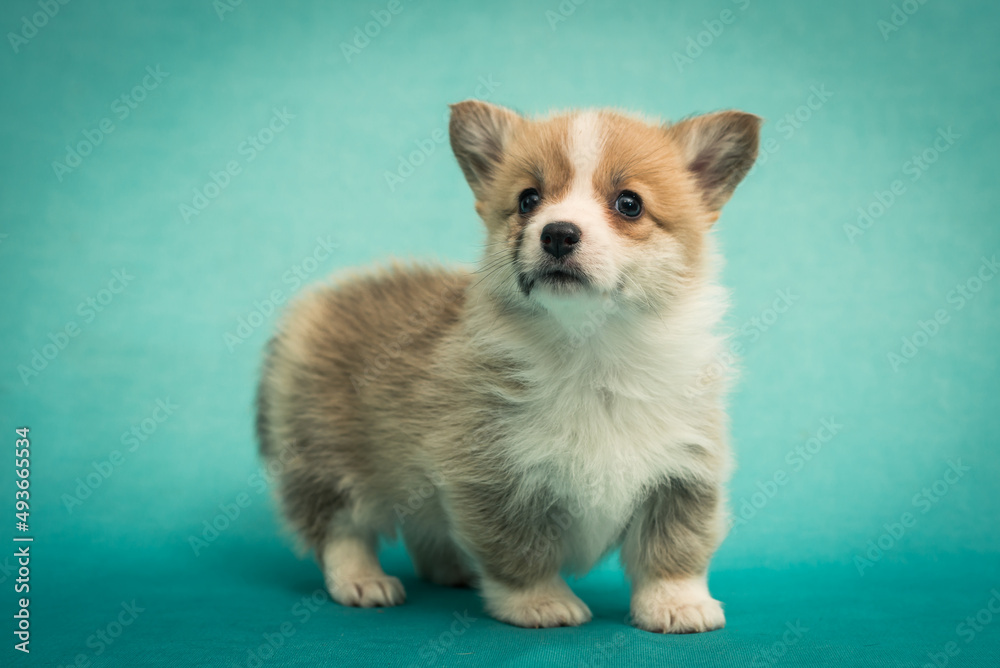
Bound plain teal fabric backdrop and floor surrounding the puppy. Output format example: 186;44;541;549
0;0;1000;666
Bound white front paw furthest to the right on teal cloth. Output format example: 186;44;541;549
632;578;726;633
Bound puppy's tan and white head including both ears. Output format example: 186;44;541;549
450;100;761;314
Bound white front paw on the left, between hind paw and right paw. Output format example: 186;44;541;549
483;577;592;629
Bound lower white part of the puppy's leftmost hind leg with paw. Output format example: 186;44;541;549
319;511;406;608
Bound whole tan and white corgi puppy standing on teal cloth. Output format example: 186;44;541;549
257;100;761;633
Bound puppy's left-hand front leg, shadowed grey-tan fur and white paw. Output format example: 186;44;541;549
452;487;591;628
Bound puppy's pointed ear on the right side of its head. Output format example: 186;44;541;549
667;111;763;211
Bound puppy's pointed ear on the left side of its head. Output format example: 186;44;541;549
448;100;522;201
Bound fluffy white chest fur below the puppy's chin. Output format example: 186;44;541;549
482;294;724;570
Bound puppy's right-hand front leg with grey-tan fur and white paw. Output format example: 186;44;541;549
622;480;726;633
